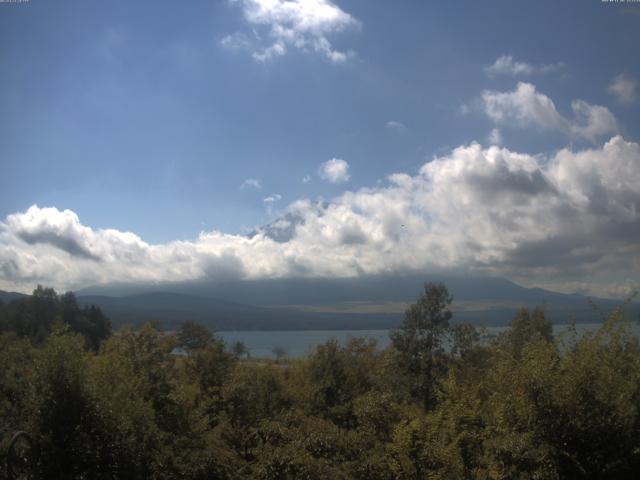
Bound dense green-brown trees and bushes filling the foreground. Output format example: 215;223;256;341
0;284;640;479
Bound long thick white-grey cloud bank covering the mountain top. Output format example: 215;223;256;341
0;136;640;291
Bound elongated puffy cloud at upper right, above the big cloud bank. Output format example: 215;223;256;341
482;82;618;142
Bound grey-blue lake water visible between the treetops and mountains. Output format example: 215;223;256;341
218;323;640;358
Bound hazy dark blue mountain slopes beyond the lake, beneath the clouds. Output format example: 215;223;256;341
78;275;640;330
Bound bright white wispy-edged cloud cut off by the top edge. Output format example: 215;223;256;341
221;0;360;63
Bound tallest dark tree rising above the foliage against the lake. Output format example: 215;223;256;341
390;283;453;410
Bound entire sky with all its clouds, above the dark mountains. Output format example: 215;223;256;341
0;0;640;298
